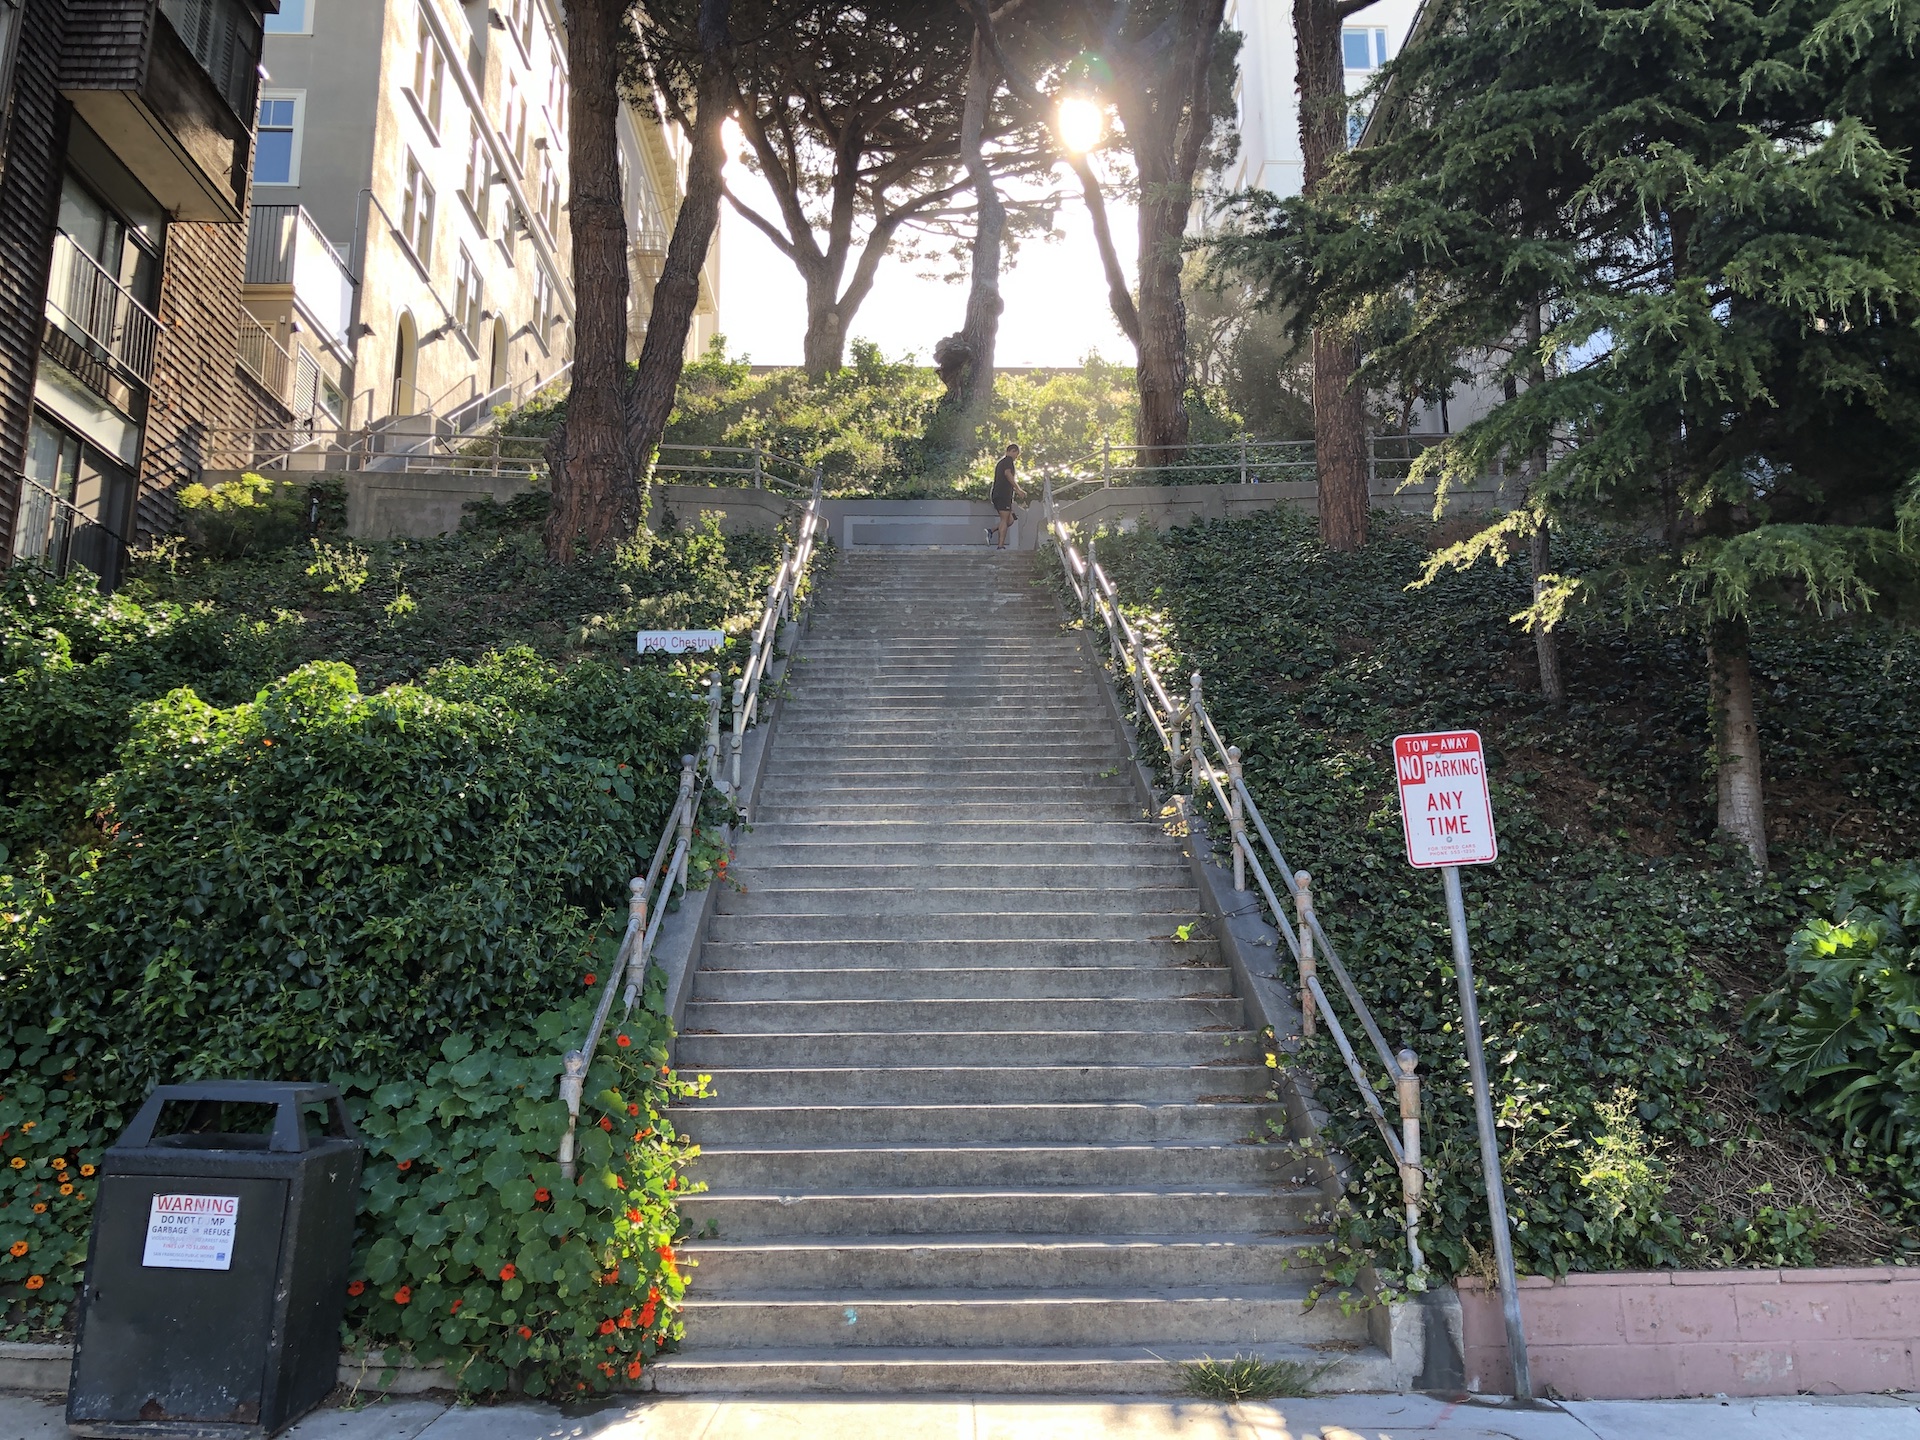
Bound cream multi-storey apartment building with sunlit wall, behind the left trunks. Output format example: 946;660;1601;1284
248;0;712;443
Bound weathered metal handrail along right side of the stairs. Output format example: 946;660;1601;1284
1041;476;1427;1273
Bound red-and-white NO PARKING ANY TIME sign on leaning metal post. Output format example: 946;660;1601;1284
1394;730;1534;1400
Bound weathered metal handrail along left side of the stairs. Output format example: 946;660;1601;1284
559;468;826;1179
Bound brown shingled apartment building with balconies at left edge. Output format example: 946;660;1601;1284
0;0;280;584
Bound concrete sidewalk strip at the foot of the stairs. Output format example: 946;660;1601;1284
0;1396;1920;1440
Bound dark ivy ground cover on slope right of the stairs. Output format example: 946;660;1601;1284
1100;511;1920;1279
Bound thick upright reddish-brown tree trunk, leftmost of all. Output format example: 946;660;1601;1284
545;0;637;564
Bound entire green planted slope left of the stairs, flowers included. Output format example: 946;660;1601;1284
0;515;772;1394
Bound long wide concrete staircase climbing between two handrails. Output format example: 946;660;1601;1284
655;551;1384;1392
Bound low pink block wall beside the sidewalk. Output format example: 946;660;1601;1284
1459;1265;1920;1400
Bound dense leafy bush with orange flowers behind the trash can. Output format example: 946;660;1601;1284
0;651;701;1390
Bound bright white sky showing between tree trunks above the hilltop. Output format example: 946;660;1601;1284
720;146;1137;365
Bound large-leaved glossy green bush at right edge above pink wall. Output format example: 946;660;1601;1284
1749;860;1920;1210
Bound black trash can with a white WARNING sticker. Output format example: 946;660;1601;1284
67;1081;363;1440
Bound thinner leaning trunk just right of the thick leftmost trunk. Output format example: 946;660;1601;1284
626;0;733;485
